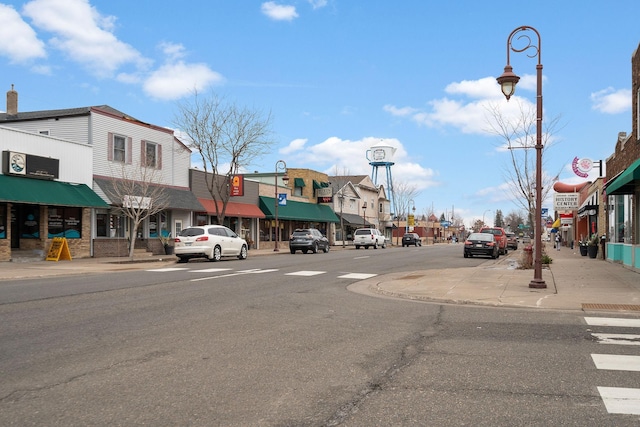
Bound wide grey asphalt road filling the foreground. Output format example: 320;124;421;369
0;245;640;426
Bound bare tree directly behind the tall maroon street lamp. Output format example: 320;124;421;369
487;101;561;224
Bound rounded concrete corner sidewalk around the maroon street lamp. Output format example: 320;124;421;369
351;244;640;316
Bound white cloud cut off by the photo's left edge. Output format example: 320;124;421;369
0;4;47;63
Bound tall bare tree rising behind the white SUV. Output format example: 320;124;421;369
173;91;273;224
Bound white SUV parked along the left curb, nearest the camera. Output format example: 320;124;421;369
174;225;248;262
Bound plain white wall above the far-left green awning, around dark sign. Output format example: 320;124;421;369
0;123;93;187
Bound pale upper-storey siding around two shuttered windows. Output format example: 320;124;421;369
91;112;191;188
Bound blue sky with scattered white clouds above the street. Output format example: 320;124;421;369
0;0;640;225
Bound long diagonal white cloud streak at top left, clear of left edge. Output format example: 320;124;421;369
23;0;148;77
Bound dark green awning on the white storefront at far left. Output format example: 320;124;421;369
0;175;109;208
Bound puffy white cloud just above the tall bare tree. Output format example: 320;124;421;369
143;61;224;100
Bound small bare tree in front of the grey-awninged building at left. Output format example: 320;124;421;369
104;164;169;260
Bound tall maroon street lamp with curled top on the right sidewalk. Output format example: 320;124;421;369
497;26;547;289
